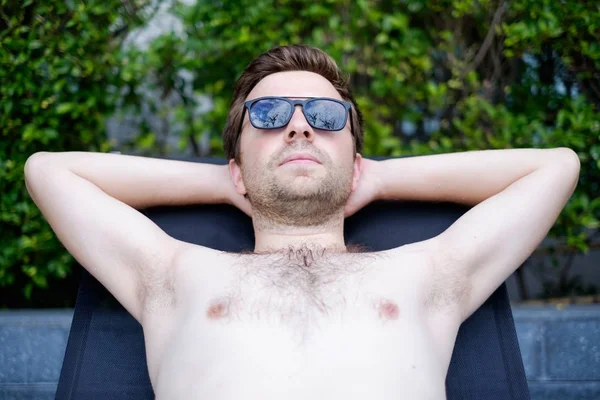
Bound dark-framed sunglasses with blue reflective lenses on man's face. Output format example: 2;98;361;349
239;96;354;133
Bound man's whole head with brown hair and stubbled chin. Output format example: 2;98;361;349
223;46;363;230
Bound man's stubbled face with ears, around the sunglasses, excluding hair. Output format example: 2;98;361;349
230;71;361;226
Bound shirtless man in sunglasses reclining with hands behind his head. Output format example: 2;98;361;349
25;46;579;400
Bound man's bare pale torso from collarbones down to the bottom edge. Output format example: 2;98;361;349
142;245;461;399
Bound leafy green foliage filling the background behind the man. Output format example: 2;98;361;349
0;0;600;305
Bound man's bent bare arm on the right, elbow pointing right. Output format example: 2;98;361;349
377;148;580;322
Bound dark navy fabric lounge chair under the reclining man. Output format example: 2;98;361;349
56;158;530;400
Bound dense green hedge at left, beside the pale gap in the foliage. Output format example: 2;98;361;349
0;0;154;307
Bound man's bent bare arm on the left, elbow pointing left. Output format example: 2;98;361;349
25;152;244;322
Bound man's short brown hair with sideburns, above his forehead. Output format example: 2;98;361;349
223;45;363;163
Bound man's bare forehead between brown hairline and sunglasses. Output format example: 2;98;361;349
246;71;342;100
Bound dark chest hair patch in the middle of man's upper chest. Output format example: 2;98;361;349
217;247;384;329
